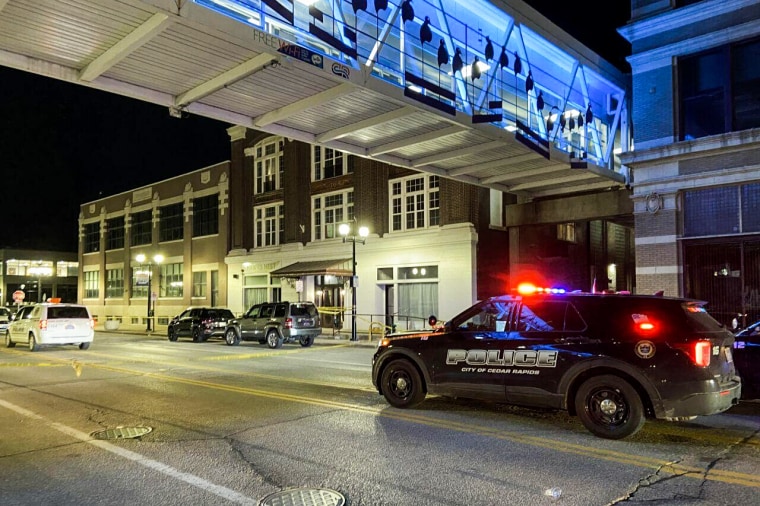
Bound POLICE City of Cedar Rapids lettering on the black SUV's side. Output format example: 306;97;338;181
446;349;558;374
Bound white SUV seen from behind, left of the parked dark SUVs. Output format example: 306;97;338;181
5;303;95;351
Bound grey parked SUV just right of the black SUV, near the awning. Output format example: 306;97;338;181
224;302;322;348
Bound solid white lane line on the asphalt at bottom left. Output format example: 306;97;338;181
0;399;258;505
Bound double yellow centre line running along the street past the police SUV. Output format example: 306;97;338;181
5;353;760;488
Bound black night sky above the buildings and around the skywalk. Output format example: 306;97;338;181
0;0;630;251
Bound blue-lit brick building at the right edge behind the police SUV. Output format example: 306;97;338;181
620;0;760;323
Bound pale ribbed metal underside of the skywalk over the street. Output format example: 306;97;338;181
0;0;626;200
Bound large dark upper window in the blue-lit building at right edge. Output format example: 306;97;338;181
678;40;760;140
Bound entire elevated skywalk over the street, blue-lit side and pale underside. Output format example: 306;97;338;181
0;0;628;202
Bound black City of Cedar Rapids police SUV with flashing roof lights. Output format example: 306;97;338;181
372;289;741;439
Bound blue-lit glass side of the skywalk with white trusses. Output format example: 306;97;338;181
194;0;627;168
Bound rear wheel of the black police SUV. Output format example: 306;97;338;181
575;375;646;439
